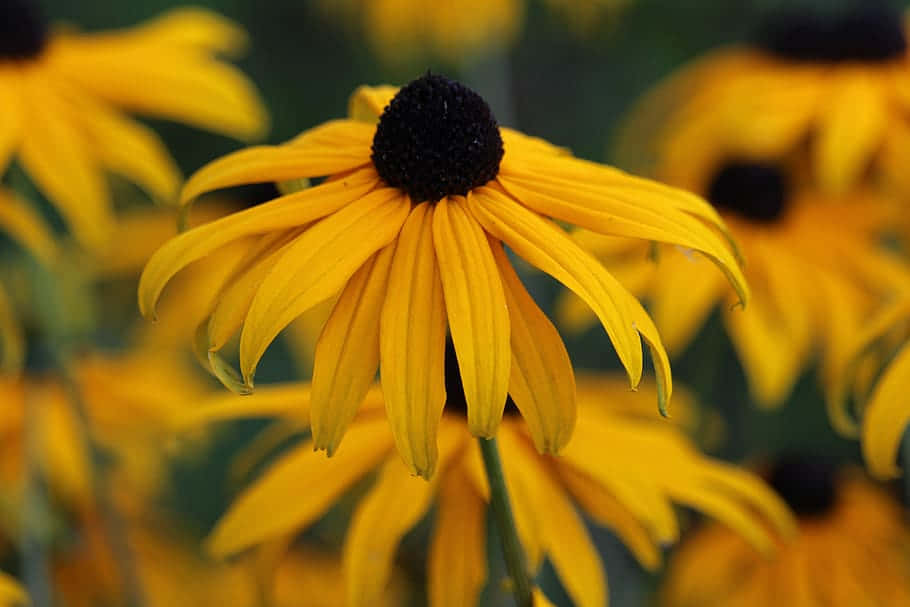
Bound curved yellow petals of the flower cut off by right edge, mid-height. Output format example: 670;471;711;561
832;298;910;478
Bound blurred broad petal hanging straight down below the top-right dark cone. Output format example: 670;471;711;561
813;70;890;192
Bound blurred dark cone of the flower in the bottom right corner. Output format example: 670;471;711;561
768;456;837;517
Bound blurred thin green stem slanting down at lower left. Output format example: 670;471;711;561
58;356;147;607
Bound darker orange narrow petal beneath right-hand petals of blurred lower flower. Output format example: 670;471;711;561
558;466;663;571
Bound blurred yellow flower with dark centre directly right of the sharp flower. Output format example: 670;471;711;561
558;161;910;410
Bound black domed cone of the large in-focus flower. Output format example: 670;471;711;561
372;74;503;204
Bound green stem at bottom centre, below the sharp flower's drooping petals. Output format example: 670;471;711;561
477;438;533;607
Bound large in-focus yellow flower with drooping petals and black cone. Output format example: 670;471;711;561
139;74;746;476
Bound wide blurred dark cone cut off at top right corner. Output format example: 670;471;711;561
756;0;907;63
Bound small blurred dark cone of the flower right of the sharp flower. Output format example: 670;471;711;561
708;162;787;223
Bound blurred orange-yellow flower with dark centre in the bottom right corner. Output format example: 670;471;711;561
659;461;910;607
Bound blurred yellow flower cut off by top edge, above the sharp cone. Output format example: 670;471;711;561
321;0;525;63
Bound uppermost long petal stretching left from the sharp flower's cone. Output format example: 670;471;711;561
180;120;378;204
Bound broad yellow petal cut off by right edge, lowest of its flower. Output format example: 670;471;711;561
862;345;910;479
